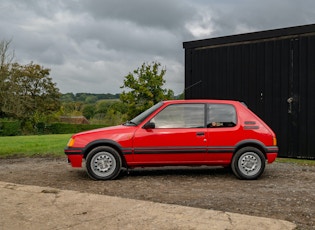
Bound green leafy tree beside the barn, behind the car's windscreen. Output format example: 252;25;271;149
120;62;174;119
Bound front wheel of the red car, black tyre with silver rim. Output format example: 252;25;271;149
86;146;122;180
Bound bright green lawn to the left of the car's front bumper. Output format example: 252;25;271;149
0;134;71;158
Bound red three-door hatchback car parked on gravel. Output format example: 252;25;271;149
65;100;278;180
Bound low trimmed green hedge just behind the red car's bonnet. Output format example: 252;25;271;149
45;123;104;134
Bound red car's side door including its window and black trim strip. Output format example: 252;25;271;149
133;103;207;165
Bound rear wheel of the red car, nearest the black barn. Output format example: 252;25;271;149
231;147;266;180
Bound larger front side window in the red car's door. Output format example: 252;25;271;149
151;104;205;128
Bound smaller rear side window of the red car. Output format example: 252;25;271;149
207;104;236;128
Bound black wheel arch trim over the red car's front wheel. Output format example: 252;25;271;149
83;139;127;167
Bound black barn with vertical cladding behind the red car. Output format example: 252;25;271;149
183;24;315;159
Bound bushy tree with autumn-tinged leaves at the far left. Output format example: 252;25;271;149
1;62;61;126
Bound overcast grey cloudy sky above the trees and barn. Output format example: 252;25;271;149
0;0;315;94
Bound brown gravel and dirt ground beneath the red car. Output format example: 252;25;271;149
0;158;315;229
